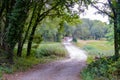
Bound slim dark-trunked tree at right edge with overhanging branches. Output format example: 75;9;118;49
88;0;120;56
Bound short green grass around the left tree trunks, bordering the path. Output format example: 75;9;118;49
11;44;60;72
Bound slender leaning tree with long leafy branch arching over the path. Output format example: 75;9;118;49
27;0;88;56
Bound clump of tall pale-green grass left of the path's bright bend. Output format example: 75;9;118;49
35;43;67;58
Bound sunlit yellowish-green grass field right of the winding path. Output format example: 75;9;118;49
76;40;114;57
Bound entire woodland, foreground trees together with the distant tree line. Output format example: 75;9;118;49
0;0;120;79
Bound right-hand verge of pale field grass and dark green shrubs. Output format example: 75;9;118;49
76;40;120;80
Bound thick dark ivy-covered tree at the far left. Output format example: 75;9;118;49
0;0;29;63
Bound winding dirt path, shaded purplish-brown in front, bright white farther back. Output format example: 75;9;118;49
2;43;87;80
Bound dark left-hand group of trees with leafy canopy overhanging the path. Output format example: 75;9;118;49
0;0;83;63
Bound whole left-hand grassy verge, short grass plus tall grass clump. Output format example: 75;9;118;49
0;43;67;77
